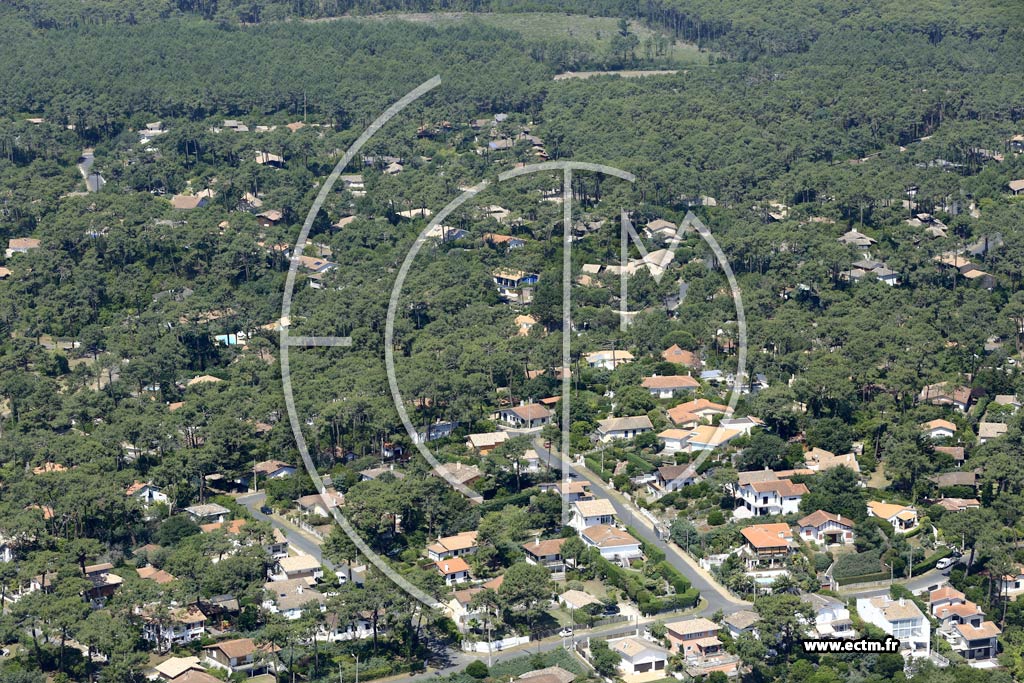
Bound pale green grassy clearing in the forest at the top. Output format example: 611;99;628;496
331;12;708;66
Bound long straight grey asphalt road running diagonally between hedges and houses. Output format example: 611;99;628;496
534;439;751;614
